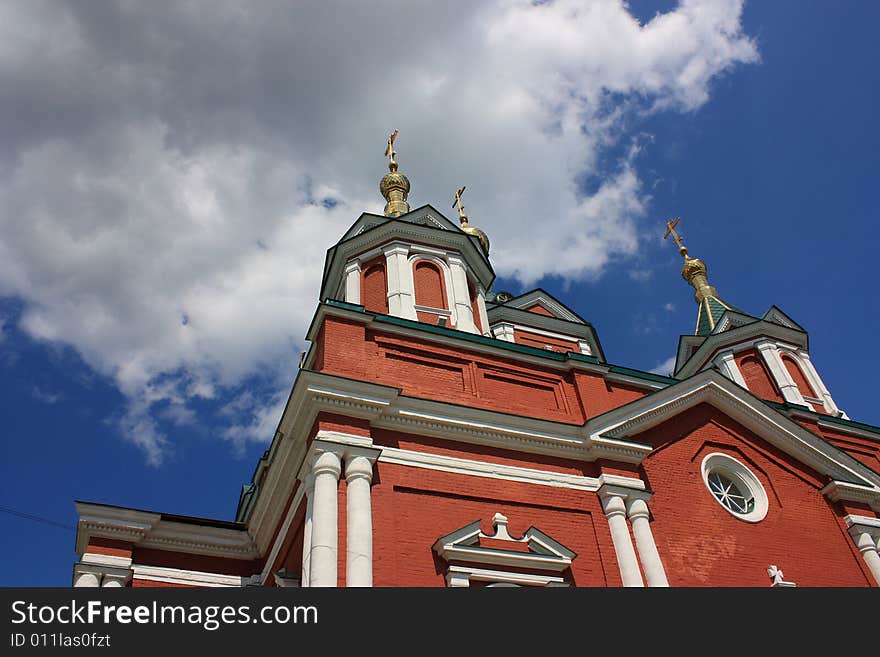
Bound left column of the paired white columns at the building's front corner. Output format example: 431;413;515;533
309;452;342;586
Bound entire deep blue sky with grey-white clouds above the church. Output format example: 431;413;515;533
0;1;880;586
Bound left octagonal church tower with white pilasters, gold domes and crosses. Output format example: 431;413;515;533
321;130;495;335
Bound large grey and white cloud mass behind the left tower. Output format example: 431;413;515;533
0;0;758;463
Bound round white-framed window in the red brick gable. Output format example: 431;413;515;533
702;452;767;522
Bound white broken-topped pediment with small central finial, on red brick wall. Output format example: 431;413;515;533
433;513;577;586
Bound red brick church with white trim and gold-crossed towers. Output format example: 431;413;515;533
73;137;880;587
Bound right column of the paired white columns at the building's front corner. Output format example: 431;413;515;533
345;455;373;586
